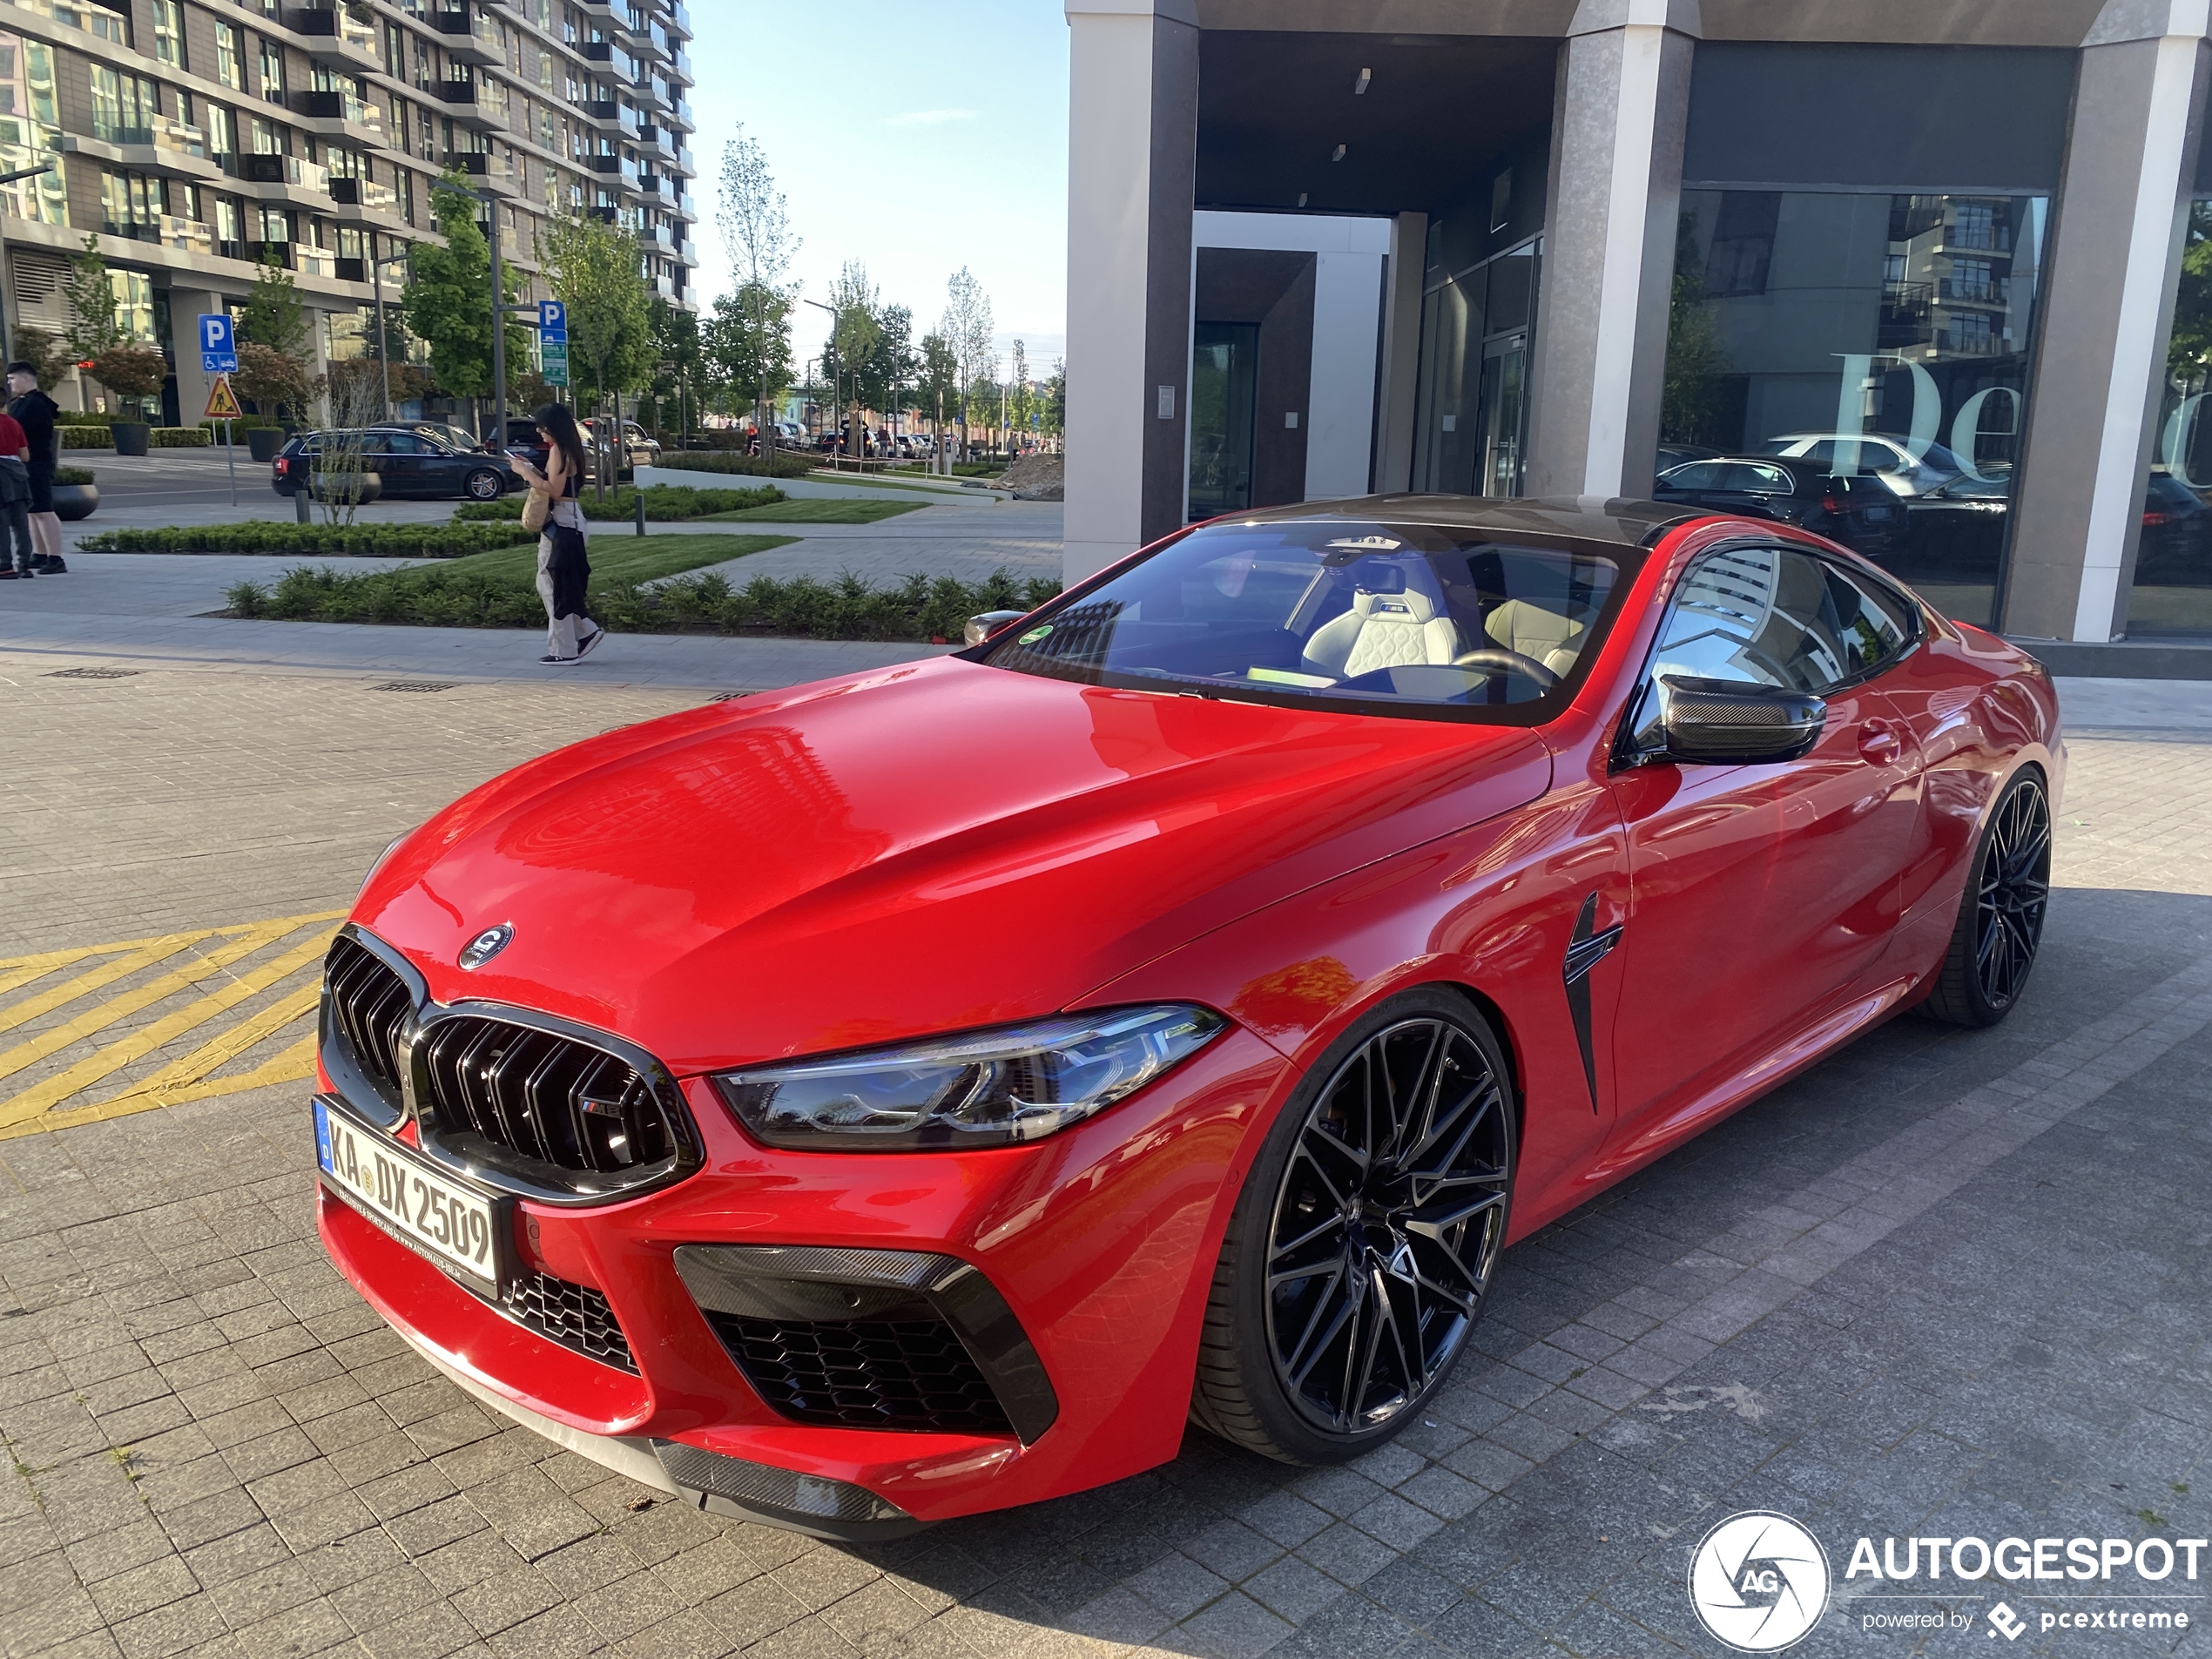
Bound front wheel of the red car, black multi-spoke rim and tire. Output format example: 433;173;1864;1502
1190;987;1517;1464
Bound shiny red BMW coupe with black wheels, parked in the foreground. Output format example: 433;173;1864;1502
314;496;2064;1537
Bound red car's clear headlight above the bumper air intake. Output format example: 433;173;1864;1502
714;1004;1228;1152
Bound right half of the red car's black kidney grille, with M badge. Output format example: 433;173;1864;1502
416;1015;679;1175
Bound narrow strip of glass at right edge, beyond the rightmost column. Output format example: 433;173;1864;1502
2128;197;2212;637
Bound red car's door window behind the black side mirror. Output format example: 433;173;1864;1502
1652;546;1913;697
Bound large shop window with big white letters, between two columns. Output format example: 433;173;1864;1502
1655;190;2048;626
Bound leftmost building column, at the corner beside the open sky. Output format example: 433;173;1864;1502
1062;0;1199;582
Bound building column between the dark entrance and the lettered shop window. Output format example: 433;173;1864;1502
1527;0;1699;498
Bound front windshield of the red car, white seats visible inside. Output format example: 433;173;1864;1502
982;520;1619;719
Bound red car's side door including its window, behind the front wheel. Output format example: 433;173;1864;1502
1613;544;1920;1139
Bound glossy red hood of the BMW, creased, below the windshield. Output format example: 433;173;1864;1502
354;657;1551;1073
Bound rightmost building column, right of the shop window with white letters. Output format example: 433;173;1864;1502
2002;0;2208;644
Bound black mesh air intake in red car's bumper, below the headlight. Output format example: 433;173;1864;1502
708;1312;1011;1433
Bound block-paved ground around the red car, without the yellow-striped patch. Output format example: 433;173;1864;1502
0;675;2212;1659
